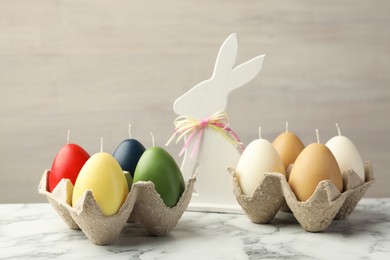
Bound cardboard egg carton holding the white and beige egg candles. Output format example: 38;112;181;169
229;161;374;232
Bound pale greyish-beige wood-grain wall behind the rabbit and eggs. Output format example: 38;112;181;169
0;0;390;203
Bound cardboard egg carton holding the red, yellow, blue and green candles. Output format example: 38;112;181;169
38;170;196;245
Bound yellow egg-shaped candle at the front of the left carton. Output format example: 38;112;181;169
72;138;129;216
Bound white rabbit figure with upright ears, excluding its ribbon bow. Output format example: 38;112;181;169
173;34;265;212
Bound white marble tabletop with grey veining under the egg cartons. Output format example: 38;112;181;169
0;199;390;259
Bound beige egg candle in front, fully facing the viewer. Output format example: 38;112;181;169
288;129;343;201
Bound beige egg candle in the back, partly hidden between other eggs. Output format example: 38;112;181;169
272;122;305;170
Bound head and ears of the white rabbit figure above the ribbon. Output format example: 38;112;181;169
173;34;265;119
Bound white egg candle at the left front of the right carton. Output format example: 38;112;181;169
236;128;286;195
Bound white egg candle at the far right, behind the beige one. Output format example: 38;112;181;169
325;124;365;181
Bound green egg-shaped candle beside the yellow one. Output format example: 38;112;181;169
134;136;185;207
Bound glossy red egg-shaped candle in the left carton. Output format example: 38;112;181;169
49;131;90;192
